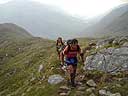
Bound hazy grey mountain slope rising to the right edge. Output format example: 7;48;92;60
81;4;128;37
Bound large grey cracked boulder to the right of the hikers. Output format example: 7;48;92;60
83;47;128;73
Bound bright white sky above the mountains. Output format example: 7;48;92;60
0;0;127;18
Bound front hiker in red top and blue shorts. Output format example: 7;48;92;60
63;39;83;87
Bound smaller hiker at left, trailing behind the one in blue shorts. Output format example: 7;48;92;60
56;37;64;60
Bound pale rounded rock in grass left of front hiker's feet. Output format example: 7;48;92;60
48;75;64;84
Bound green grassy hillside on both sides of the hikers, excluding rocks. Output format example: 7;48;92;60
0;23;128;96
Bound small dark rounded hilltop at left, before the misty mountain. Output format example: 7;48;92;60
0;23;32;41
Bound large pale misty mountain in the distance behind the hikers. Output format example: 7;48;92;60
0;0;85;39
